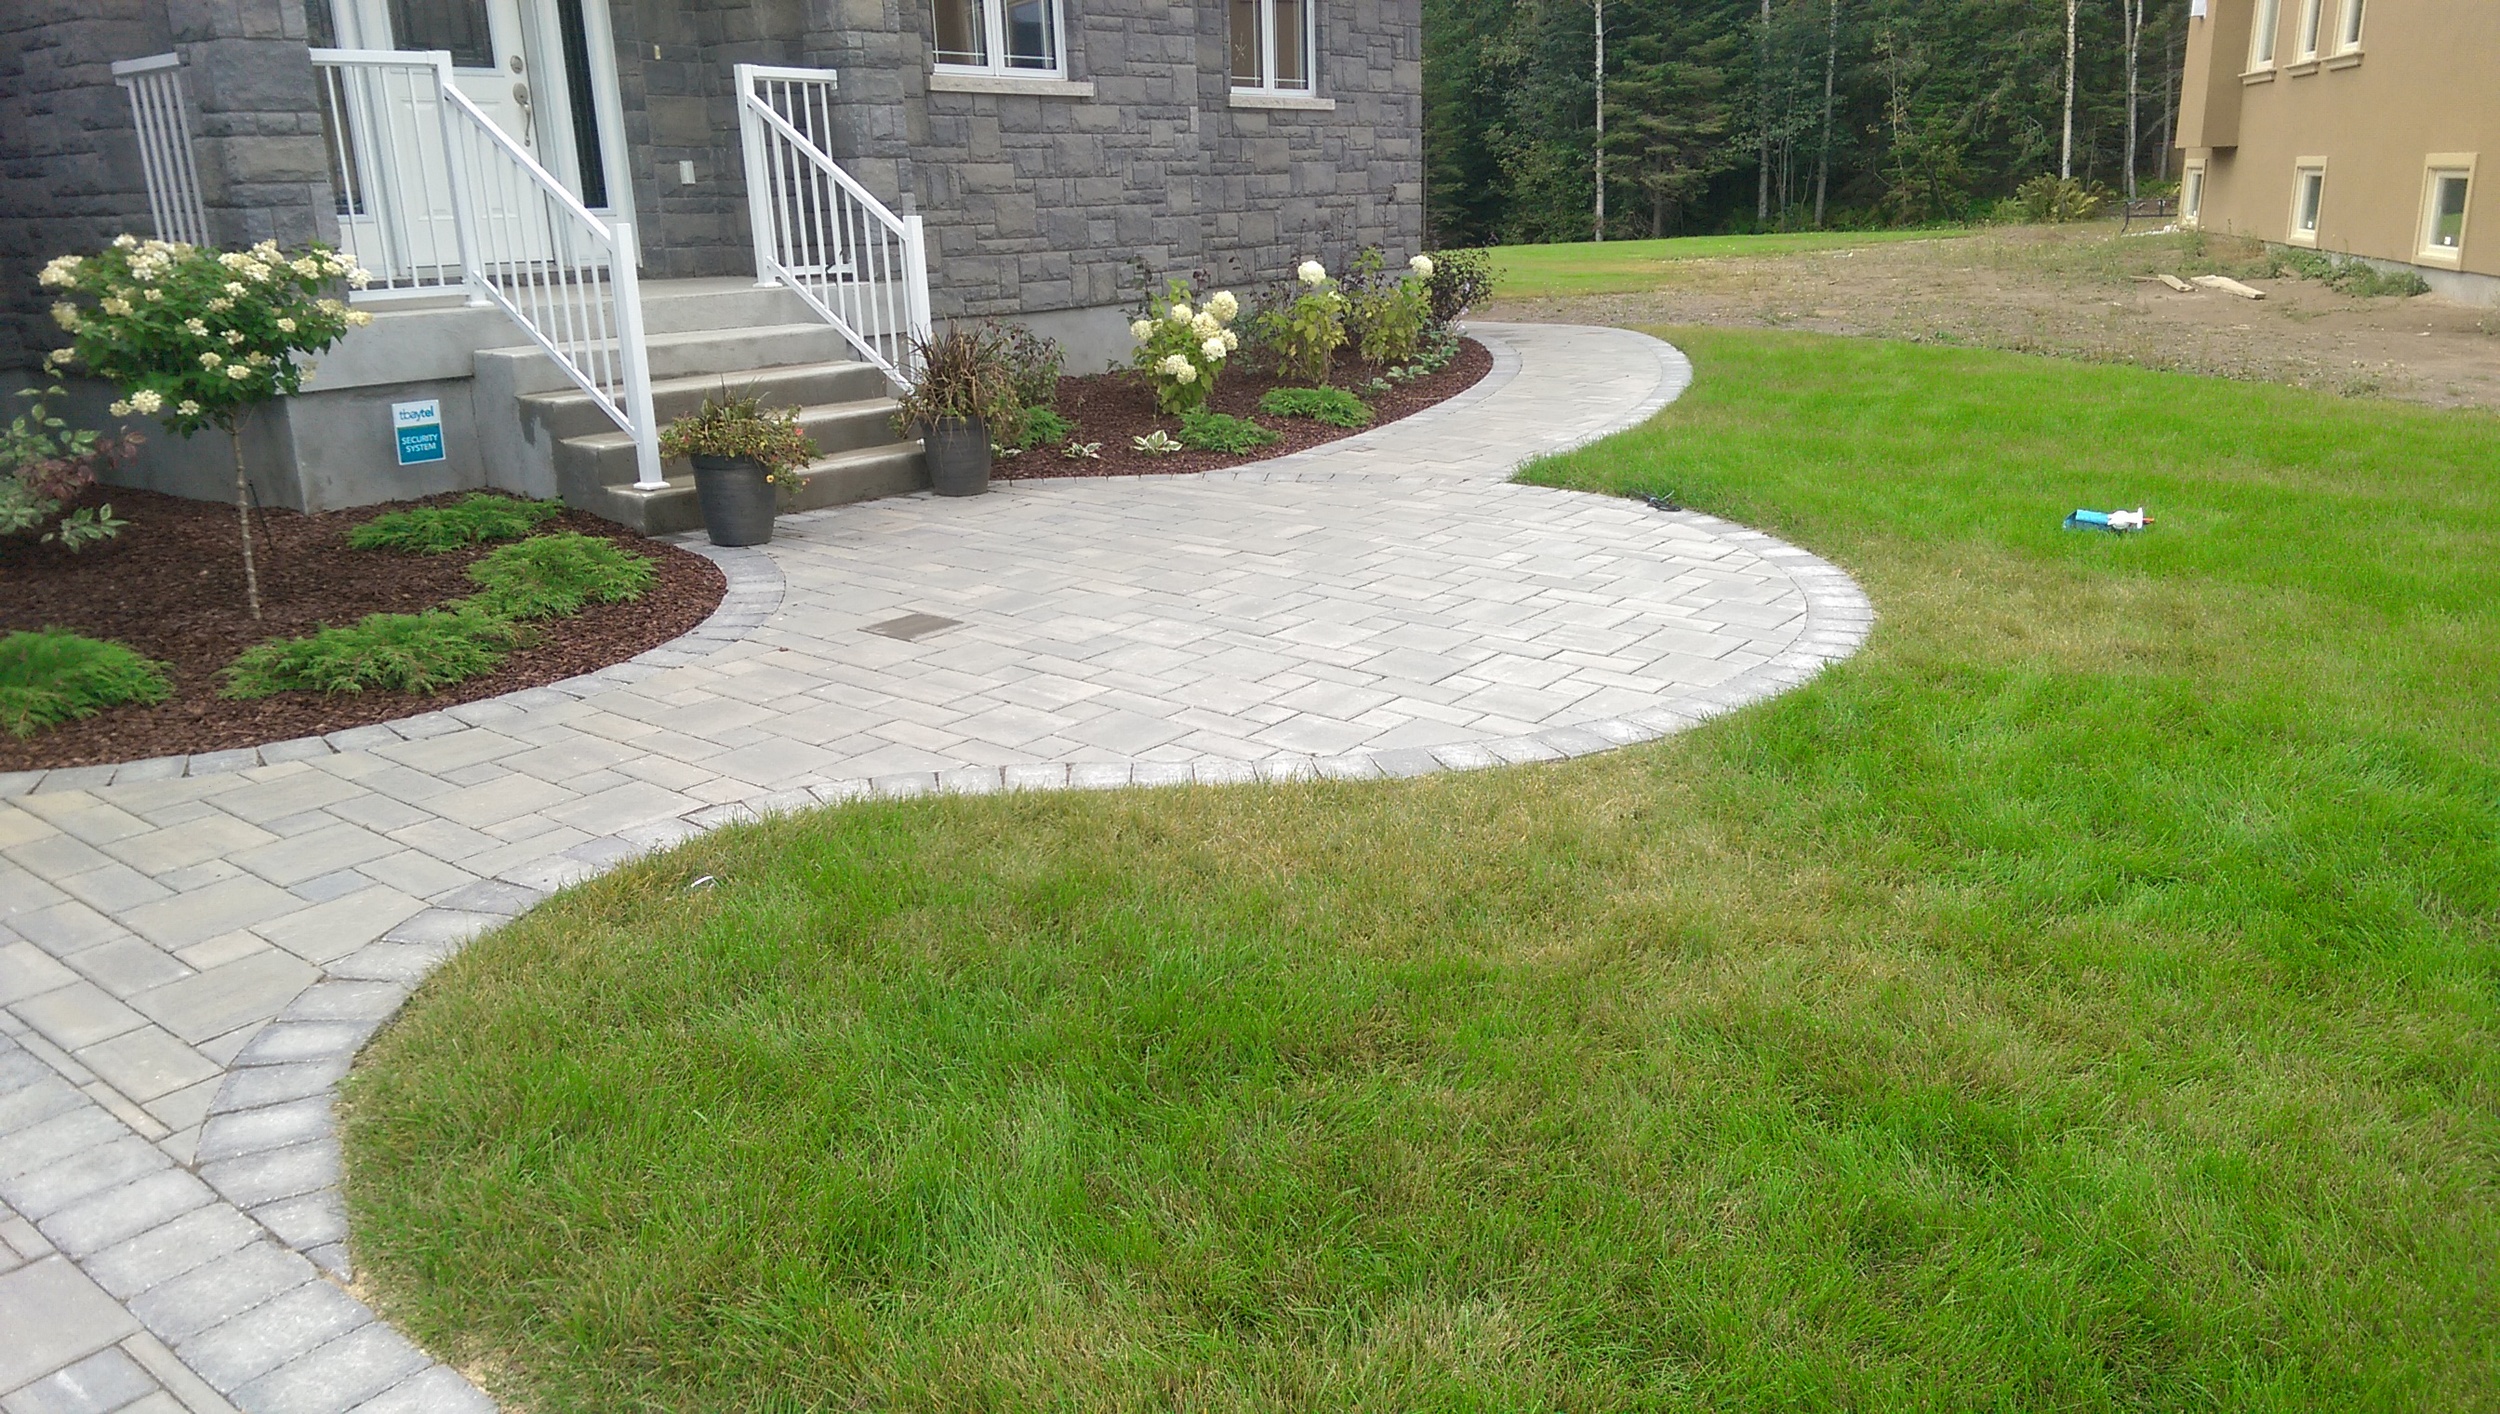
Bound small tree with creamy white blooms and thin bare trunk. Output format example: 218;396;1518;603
40;235;373;620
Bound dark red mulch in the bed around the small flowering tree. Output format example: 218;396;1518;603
0;487;728;772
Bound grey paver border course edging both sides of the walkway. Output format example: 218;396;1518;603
0;325;1875;1412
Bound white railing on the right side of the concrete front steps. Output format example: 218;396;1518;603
738;65;930;382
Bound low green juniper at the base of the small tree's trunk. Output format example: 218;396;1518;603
225;602;535;697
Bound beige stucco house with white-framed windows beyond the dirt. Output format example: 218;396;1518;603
2180;0;2500;302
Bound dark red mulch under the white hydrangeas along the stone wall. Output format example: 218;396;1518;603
993;340;1493;480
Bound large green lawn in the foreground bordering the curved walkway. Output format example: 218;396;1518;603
345;330;2500;1414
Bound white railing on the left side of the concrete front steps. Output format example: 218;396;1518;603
313;50;663;487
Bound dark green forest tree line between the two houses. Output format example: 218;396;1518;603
1423;0;2188;247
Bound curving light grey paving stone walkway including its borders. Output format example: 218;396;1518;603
0;325;1873;1414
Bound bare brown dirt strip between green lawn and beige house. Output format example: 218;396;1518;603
1480;222;2500;410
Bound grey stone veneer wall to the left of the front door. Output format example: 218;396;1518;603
0;0;338;367
